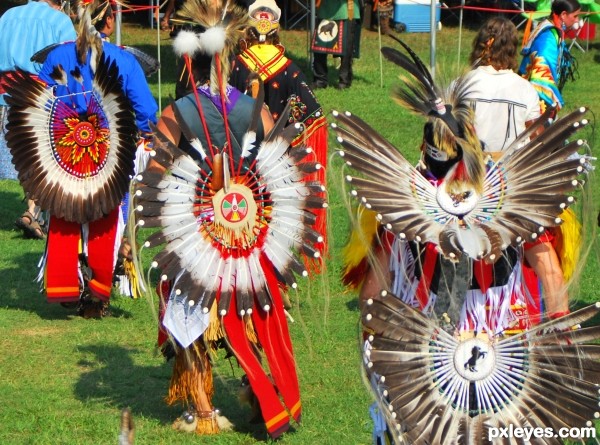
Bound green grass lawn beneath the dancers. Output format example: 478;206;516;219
0;19;600;445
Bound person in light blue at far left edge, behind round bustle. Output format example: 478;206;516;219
0;0;77;239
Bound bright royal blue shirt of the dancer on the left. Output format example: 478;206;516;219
39;42;158;133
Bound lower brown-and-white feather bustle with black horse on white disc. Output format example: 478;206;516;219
362;292;600;445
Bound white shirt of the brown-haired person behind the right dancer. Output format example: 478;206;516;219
467;66;540;151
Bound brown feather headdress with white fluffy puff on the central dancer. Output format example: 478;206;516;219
177;0;248;94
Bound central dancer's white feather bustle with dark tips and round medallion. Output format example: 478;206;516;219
136;102;326;347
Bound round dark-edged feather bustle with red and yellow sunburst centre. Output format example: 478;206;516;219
6;57;137;223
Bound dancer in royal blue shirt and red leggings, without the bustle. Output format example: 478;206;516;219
33;0;158;318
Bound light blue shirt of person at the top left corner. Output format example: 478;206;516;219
0;2;77;105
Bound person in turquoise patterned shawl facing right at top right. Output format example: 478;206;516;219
519;0;581;113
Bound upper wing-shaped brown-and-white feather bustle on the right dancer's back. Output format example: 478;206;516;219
332;42;591;263
